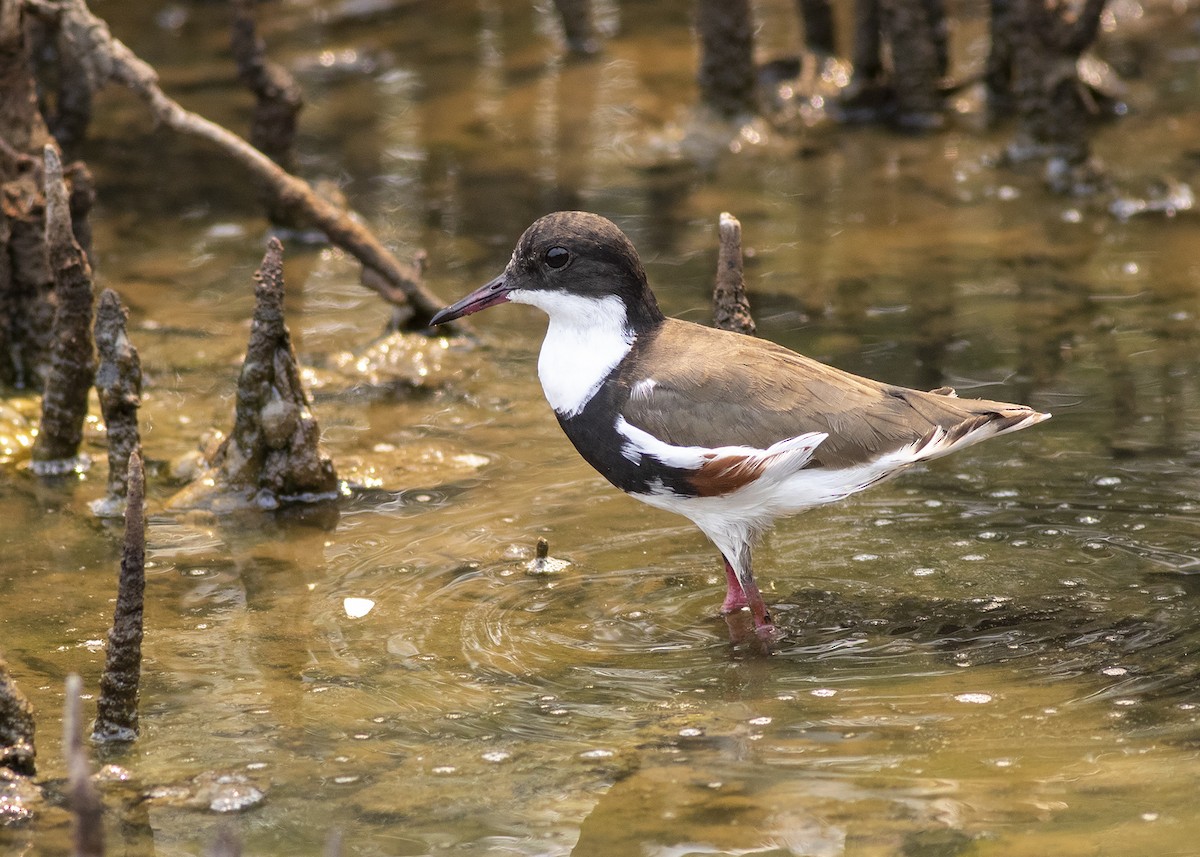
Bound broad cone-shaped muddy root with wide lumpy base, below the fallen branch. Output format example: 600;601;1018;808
170;238;337;510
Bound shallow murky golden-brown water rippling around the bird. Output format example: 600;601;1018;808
0;0;1200;857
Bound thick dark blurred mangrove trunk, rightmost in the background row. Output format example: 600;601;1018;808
1010;0;1105;192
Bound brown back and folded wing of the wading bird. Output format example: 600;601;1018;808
623;318;1033;467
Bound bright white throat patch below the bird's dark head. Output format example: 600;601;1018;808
509;289;634;418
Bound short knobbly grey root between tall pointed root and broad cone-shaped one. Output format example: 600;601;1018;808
95;289;142;513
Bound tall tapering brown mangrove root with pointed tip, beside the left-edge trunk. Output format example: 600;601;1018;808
31;145;96;475
